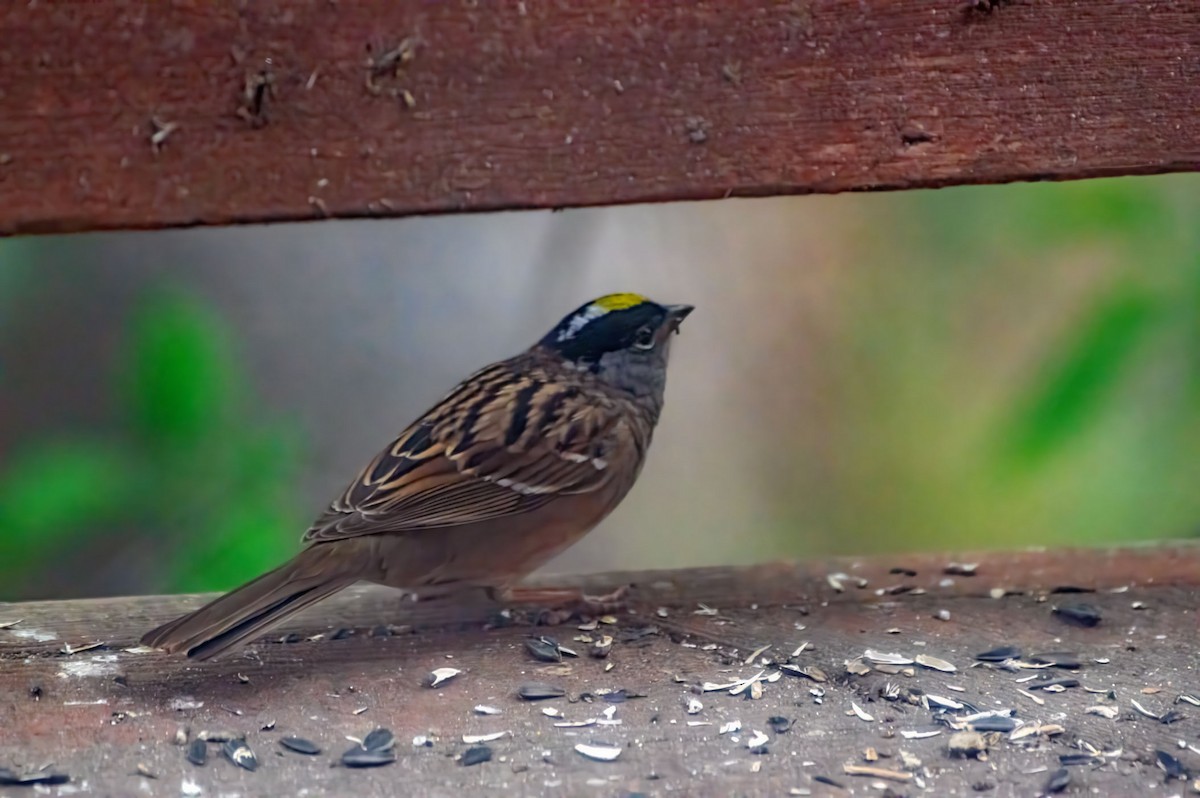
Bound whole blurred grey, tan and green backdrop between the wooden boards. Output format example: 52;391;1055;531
0;175;1200;600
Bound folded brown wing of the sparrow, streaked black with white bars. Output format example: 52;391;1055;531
304;362;642;542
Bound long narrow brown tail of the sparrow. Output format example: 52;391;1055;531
142;548;356;660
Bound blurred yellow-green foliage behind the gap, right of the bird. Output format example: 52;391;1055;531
816;175;1200;551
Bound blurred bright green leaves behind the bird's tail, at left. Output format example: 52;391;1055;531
0;286;304;595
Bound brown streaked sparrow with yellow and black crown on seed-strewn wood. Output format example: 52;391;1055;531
142;293;694;660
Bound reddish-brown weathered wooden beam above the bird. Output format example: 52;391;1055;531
0;0;1200;234
